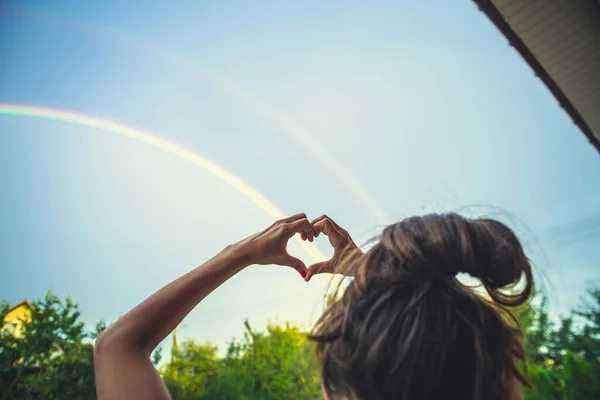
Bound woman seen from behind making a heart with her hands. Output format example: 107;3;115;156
94;213;533;400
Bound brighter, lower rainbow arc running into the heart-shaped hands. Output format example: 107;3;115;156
0;103;325;262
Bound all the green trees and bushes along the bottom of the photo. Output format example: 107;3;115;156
0;289;600;400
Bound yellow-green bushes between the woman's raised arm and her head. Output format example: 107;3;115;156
161;321;322;400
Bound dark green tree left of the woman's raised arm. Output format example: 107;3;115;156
0;292;95;400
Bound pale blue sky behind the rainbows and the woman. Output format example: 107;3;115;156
0;0;600;356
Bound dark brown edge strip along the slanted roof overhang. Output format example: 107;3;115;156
473;0;600;153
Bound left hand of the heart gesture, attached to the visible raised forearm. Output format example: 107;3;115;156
234;214;314;278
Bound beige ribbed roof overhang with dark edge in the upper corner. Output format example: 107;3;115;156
474;0;600;151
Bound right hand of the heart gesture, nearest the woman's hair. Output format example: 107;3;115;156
301;215;363;282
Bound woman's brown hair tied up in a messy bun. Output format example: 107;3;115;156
309;213;533;400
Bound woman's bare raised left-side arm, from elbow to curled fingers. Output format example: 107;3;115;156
94;214;312;400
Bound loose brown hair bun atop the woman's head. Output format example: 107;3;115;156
381;213;532;305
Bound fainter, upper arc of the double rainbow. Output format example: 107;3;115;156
3;4;389;223
